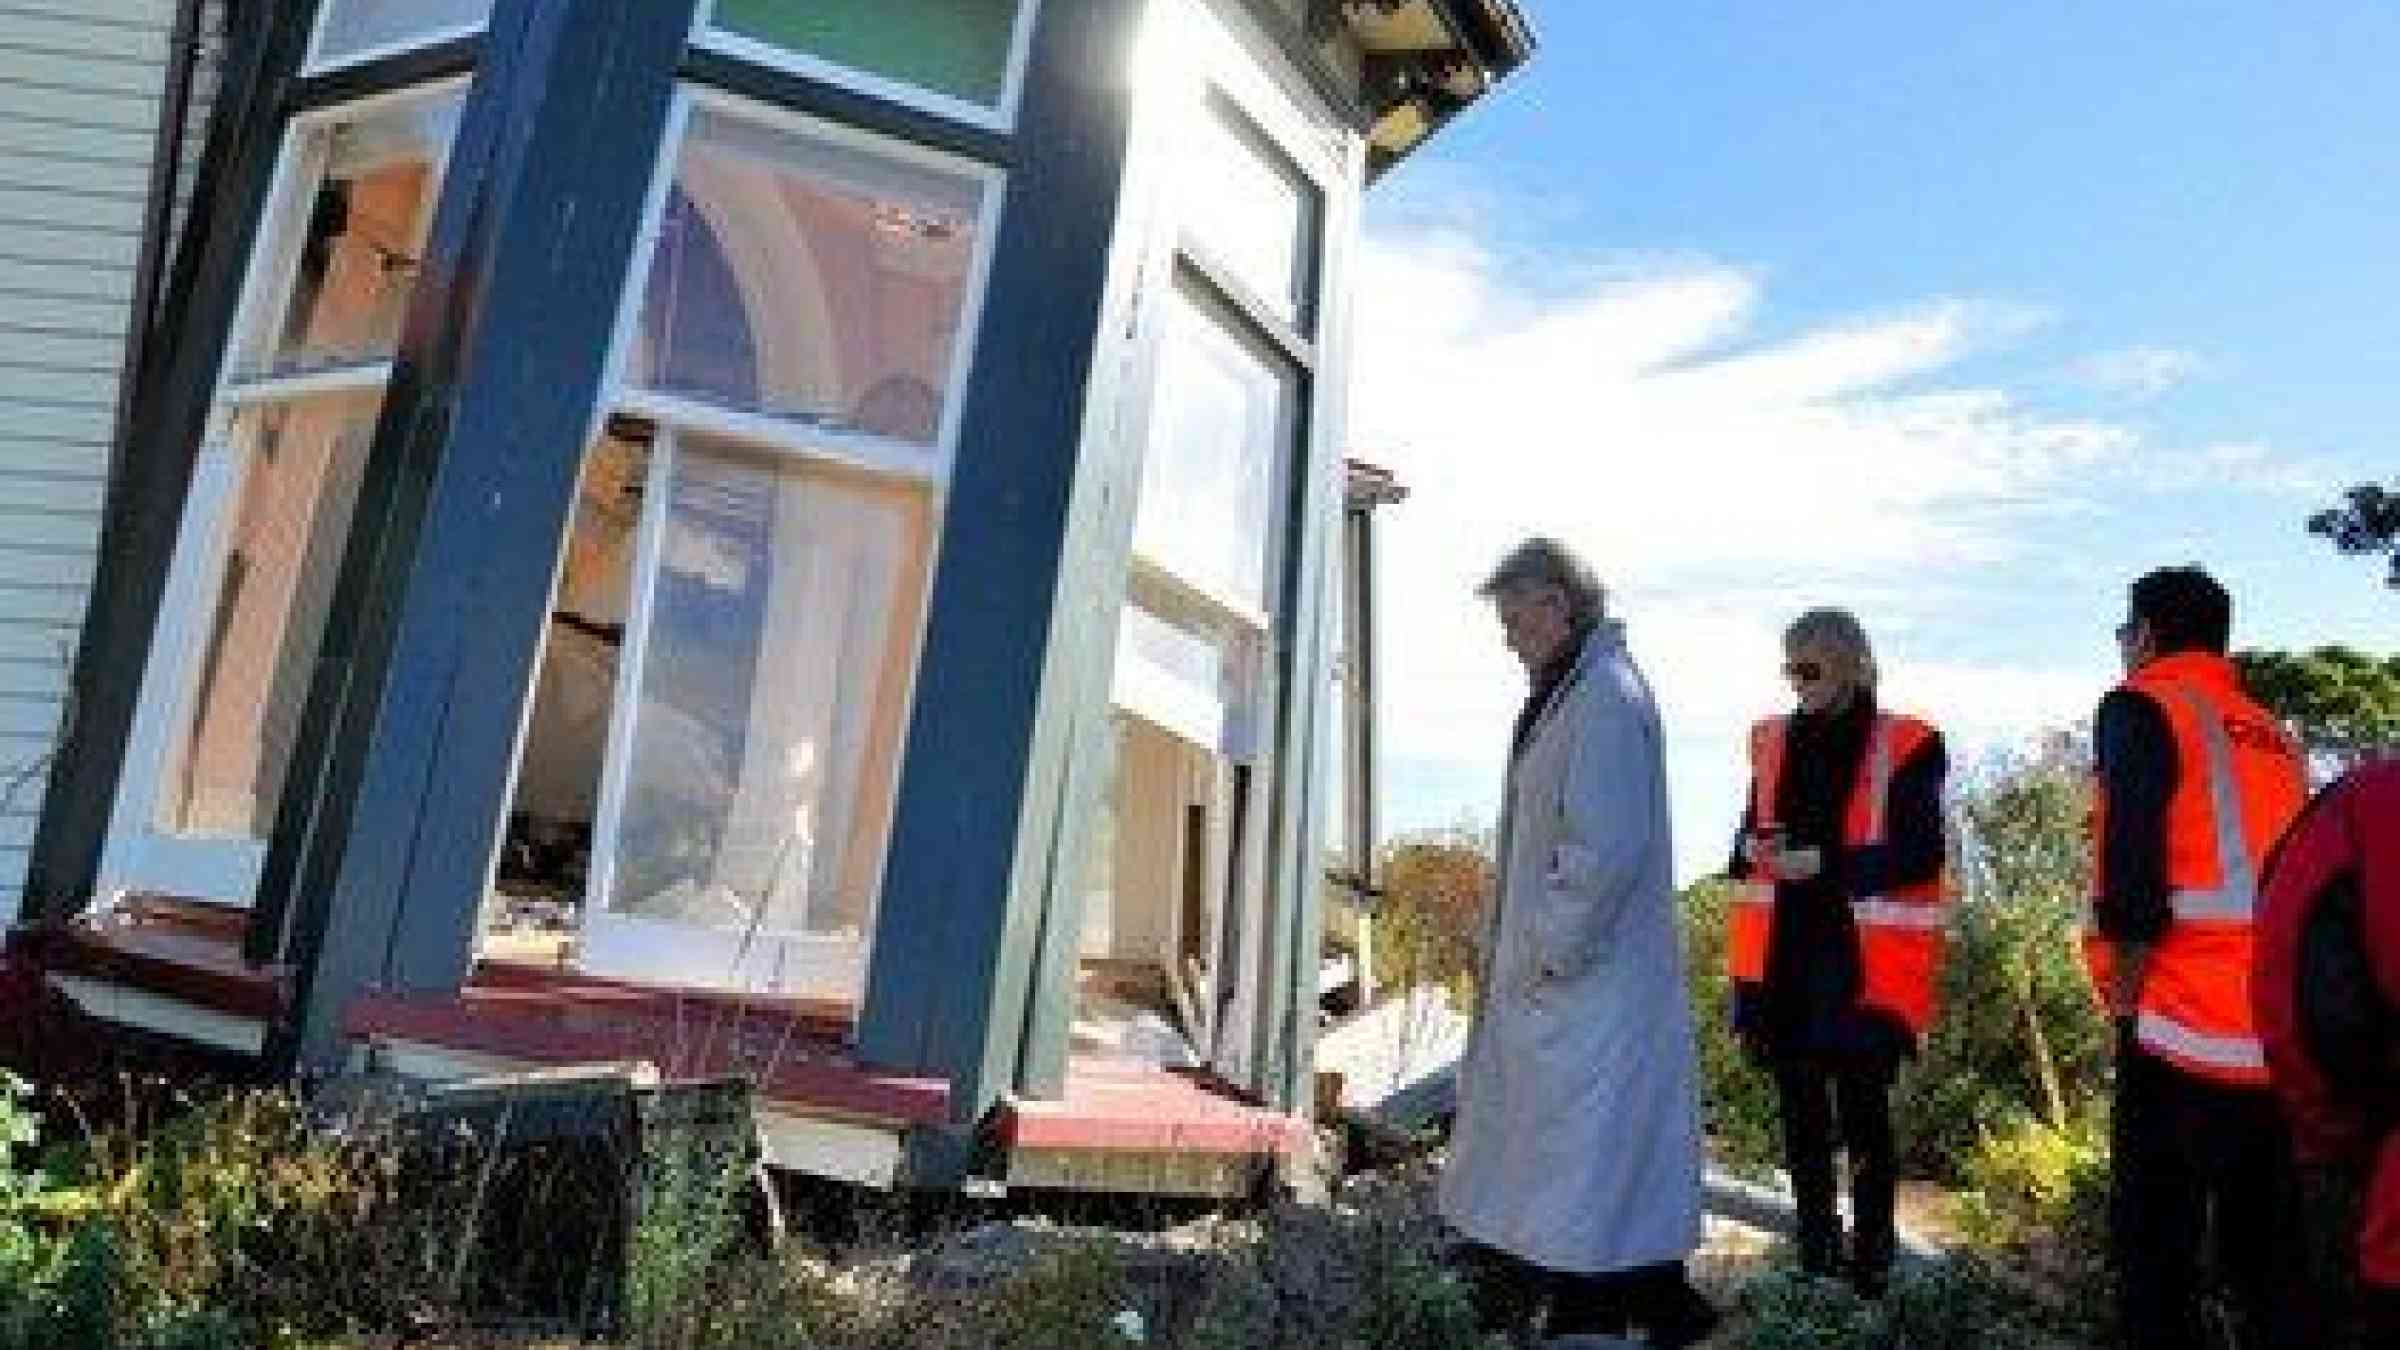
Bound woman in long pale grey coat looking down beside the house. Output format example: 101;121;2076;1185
1440;538;1716;1345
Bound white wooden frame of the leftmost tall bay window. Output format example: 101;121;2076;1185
96;77;466;908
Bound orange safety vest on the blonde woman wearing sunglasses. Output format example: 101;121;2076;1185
1726;713;1949;1035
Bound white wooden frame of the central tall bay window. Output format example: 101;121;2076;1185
511;82;1008;1002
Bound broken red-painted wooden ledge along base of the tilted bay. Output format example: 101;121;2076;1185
12;901;1310;1194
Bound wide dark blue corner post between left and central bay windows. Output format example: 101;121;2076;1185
269;0;691;1064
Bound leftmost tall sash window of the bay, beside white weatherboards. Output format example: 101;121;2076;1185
101;86;461;903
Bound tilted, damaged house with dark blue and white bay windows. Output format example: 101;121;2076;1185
0;0;1531;1189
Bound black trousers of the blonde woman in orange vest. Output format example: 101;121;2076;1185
1774;1057;1898;1285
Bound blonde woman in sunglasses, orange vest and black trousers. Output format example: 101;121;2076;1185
1726;610;1949;1295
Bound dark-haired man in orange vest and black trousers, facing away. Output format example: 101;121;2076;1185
2083;567;2316;1350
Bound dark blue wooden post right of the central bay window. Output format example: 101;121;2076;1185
859;0;1142;1119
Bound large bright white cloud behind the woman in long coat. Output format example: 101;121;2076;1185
1351;233;2141;874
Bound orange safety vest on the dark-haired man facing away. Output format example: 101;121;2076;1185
2083;651;2309;1086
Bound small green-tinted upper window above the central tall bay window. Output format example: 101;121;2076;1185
701;0;1034;123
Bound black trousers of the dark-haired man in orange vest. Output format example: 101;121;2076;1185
2110;1031;2326;1350
